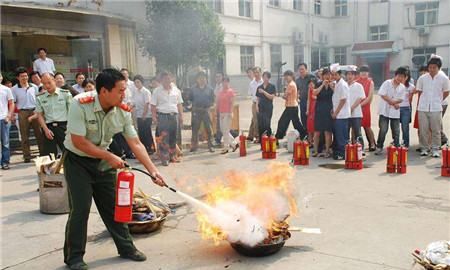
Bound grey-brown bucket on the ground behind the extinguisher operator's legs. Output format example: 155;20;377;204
38;173;69;214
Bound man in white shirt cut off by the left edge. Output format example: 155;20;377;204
0;73;14;170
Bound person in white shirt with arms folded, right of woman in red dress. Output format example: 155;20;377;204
375;67;408;155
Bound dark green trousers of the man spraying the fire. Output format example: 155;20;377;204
64;151;136;265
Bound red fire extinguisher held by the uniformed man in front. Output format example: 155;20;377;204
114;169;134;223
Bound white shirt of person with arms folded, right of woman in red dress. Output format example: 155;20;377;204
378;80;406;119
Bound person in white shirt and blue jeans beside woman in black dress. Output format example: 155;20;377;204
330;64;351;160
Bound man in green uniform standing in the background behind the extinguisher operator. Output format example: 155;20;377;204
35;73;72;156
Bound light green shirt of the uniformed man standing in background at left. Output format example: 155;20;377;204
36;88;72;123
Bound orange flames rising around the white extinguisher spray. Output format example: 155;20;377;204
197;163;297;245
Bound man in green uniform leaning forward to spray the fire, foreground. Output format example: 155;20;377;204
64;69;166;269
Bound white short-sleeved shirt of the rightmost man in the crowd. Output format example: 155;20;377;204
416;71;450;112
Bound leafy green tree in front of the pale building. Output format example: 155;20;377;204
141;0;225;87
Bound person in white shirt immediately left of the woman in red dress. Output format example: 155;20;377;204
346;66;366;148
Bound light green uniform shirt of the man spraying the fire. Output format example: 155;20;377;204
64;91;137;158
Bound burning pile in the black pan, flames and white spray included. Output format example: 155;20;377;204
197;163;297;247
